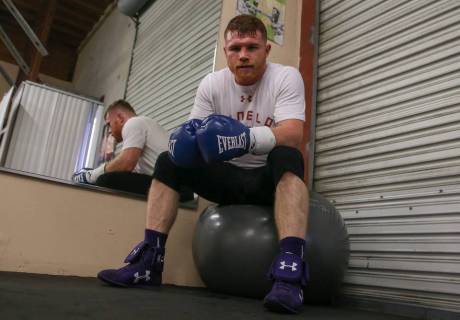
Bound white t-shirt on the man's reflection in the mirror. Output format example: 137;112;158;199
121;116;169;175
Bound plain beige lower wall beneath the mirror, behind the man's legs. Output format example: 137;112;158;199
0;171;204;287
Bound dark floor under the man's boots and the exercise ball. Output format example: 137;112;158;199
0;272;407;320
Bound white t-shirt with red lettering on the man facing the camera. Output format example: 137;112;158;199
190;63;305;168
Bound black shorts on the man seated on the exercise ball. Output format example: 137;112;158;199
153;146;303;205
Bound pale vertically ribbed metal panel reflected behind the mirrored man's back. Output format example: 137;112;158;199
4;82;103;180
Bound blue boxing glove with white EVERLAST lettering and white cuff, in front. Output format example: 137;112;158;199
196;114;276;163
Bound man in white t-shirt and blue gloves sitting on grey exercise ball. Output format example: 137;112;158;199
98;15;308;313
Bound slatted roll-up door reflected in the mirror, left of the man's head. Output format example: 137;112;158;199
126;0;221;130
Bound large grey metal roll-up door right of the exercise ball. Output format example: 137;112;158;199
313;0;460;312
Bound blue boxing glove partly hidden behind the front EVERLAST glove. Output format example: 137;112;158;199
168;119;205;168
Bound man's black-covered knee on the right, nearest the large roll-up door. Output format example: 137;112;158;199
267;146;304;186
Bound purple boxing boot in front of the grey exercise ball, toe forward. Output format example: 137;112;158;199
264;253;308;313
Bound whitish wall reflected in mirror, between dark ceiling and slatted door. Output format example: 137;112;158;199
73;9;135;106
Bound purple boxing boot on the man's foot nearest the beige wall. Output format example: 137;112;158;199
97;241;165;288
